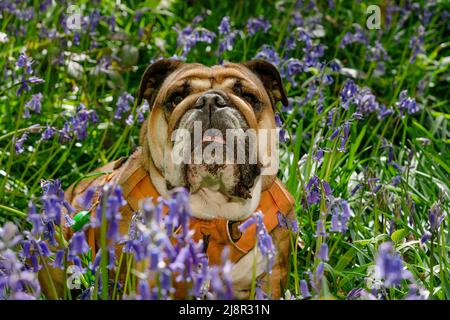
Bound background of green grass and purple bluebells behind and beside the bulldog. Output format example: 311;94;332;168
0;1;450;299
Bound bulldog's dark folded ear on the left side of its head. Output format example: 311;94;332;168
137;59;183;108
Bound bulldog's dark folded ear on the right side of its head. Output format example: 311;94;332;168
243;60;288;108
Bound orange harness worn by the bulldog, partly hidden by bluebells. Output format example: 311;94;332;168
80;157;294;264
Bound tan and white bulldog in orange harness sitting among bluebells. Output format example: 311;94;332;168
41;59;295;299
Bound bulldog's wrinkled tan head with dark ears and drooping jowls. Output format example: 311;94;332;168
139;59;287;220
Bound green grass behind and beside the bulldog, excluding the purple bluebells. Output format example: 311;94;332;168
0;1;450;299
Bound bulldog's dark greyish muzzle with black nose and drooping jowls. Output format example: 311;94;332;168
169;91;261;199
